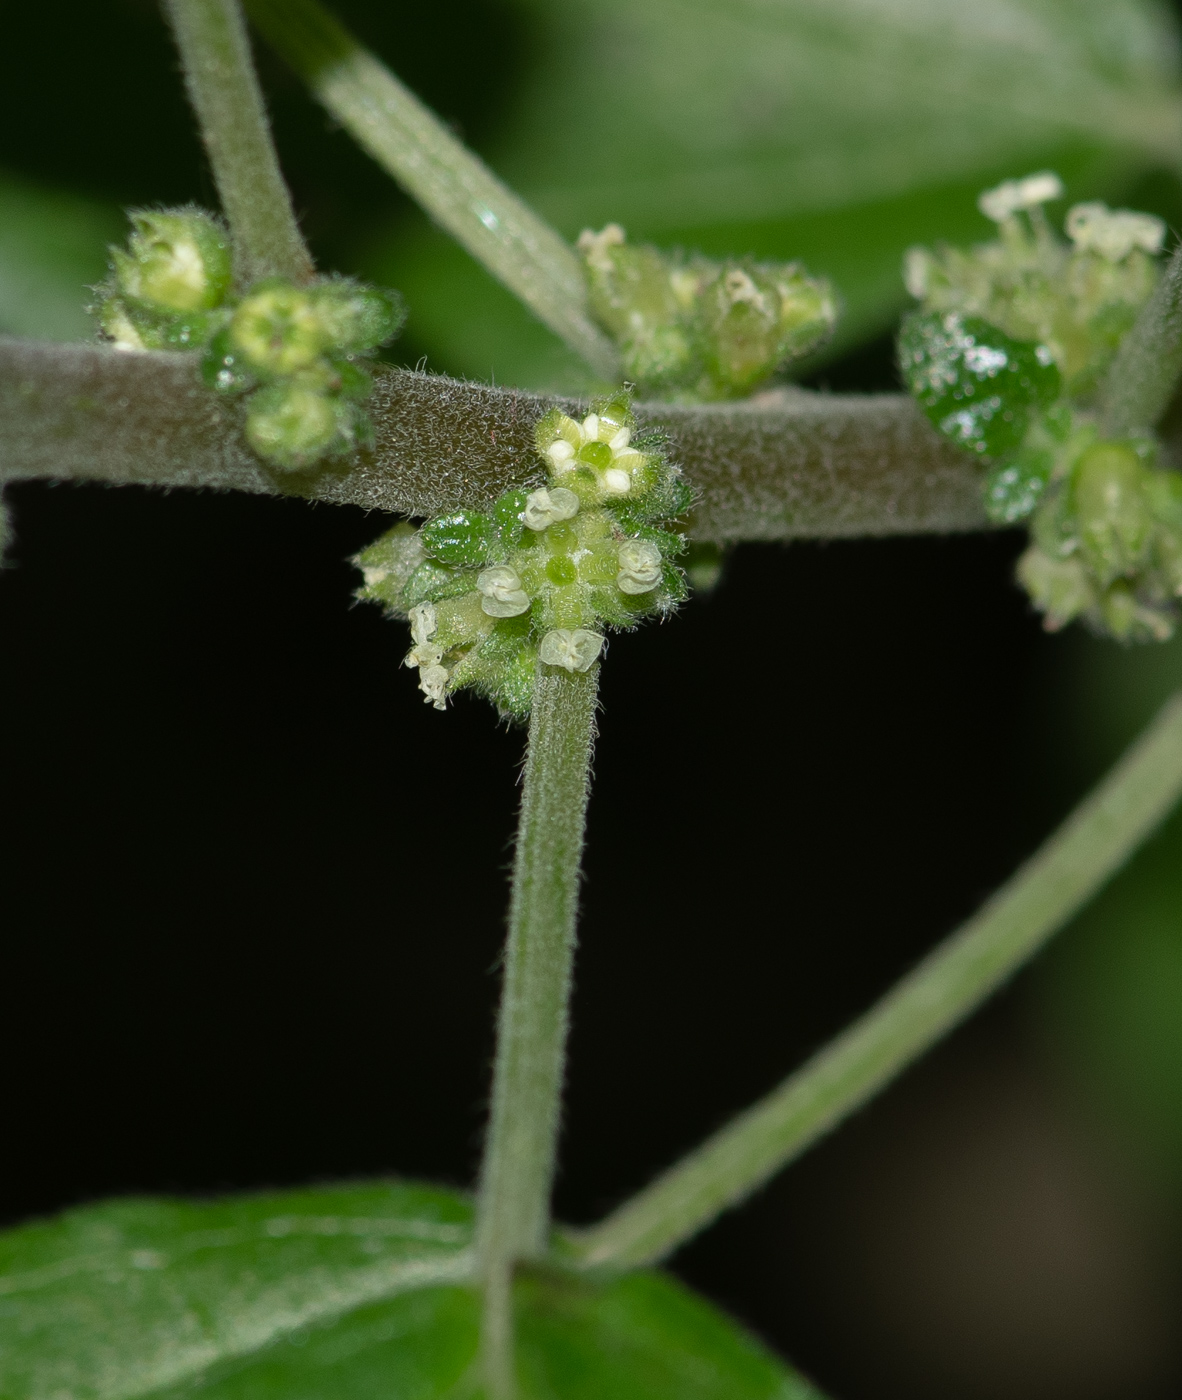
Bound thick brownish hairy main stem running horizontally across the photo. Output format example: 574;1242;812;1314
0;339;987;542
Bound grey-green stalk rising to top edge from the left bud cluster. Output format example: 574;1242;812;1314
165;0;312;286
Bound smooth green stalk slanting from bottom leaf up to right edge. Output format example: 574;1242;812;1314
571;693;1182;1268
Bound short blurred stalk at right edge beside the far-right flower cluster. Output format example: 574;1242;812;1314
1099;248;1182;437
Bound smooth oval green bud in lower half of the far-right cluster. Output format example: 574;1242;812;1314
1073;442;1154;587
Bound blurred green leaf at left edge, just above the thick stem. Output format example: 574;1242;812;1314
0;175;126;340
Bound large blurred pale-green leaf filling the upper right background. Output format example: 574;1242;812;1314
366;0;1182;388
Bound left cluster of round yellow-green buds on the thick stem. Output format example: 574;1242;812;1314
94;209;403;472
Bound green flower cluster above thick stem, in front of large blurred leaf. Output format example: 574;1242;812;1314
578;224;837;399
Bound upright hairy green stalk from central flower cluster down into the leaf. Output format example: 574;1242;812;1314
476;662;599;1400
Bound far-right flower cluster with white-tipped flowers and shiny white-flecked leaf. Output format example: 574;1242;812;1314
899;172;1182;641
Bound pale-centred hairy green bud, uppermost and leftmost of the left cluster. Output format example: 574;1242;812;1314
111;209;230;311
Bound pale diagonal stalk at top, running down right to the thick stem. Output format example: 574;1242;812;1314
246;0;619;381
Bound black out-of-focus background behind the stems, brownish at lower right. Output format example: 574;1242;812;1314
0;0;1182;1400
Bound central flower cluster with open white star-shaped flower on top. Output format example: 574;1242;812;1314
356;395;692;718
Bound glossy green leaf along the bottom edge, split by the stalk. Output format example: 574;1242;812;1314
0;1183;819;1400
